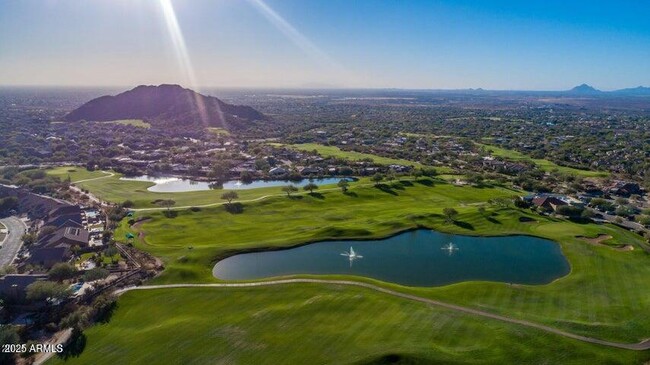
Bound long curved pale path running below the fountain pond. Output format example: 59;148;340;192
115;279;650;351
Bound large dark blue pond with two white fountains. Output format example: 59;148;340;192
213;229;570;286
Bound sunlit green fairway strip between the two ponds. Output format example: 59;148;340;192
116;179;517;281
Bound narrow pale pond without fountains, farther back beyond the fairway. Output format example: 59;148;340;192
120;175;350;193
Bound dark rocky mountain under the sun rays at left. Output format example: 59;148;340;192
64;84;267;130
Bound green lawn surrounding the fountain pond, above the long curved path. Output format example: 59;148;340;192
116;180;650;342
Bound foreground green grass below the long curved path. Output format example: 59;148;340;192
49;284;650;364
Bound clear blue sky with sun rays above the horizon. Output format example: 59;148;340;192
0;0;650;90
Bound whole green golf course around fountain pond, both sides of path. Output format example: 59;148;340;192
45;169;650;364
